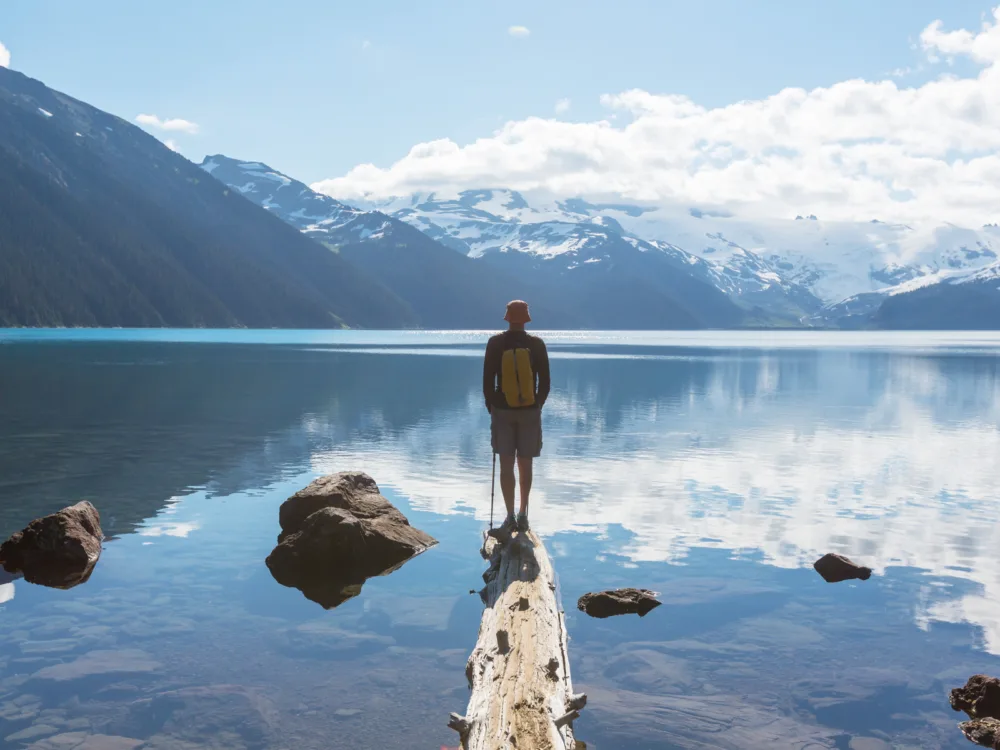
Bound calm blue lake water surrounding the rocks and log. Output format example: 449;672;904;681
0;331;1000;750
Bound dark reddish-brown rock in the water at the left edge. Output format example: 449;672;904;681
0;501;104;589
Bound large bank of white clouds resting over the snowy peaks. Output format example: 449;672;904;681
315;9;1000;227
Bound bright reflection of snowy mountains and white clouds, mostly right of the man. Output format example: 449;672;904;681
302;351;1000;653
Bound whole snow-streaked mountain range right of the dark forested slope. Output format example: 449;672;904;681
202;156;1000;328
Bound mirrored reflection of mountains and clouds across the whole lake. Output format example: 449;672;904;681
0;337;1000;653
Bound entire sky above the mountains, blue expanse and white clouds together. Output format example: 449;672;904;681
0;0;1000;226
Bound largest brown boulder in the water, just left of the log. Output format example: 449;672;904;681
266;472;437;609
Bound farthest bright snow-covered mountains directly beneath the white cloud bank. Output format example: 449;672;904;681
360;190;1000;314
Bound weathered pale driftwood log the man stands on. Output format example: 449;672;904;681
448;531;587;750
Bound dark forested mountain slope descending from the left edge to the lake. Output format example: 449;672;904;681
0;68;413;328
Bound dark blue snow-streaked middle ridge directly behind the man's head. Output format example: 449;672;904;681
202;156;747;328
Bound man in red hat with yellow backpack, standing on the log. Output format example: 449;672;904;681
483;300;550;531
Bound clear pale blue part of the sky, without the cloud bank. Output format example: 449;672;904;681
0;0;1000;225
